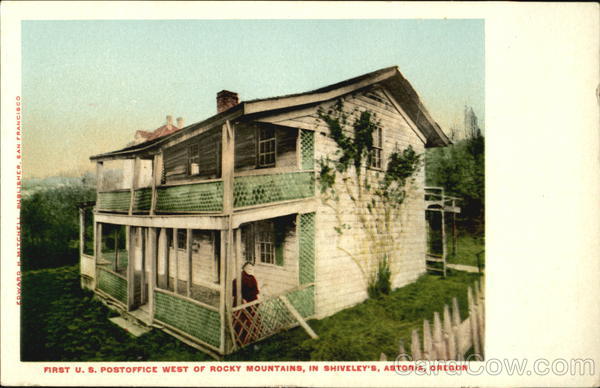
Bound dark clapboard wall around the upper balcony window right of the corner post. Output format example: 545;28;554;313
235;124;298;173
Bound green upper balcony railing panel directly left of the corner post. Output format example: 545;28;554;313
156;181;223;212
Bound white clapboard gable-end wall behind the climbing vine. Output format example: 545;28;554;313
276;90;426;317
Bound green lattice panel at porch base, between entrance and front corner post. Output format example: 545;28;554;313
154;291;221;348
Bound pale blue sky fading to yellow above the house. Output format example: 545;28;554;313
22;19;485;178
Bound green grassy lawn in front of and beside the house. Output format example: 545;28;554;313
21;266;478;361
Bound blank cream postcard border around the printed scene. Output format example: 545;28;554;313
1;2;600;386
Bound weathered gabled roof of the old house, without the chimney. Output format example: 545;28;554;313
90;66;450;160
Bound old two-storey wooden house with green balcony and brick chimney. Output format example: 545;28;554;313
81;67;449;355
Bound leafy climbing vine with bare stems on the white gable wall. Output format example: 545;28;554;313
318;99;421;296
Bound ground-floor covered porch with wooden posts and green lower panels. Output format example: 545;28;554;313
82;208;315;356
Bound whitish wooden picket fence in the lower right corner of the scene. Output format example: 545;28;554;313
380;277;485;361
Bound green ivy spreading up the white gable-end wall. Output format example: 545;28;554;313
318;99;421;297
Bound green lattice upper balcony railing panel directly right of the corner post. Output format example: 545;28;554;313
233;172;315;207
